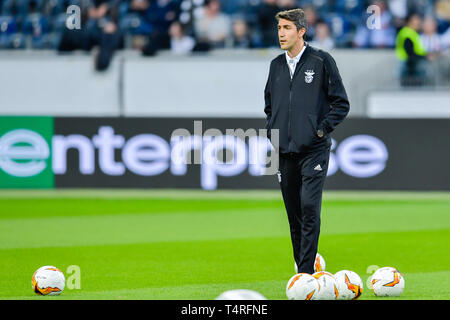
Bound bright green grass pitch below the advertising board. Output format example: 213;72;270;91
0;190;450;299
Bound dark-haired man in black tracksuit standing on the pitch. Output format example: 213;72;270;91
264;9;350;274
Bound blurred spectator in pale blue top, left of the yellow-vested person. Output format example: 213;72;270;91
353;0;396;48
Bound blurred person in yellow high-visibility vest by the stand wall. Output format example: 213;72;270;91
395;13;434;86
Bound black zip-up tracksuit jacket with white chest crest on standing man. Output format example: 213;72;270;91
264;43;350;153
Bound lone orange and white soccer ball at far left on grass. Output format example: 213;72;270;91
31;266;66;296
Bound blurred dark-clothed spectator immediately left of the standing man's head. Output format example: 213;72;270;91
258;0;280;47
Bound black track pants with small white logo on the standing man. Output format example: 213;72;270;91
278;149;330;274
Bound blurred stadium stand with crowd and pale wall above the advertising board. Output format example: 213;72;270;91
0;0;450;117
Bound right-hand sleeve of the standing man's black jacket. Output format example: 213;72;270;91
318;53;350;134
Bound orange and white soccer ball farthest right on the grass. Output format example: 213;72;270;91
370;267;405;297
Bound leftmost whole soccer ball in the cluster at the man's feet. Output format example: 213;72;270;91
286;273;319;300
